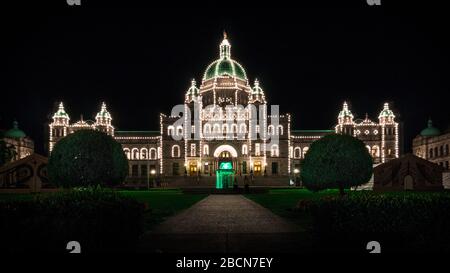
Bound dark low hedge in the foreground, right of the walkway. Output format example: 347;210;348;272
299;192;450;252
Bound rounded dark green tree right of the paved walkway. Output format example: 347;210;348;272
301;134;373;195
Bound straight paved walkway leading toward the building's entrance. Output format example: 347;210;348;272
142;194;300;253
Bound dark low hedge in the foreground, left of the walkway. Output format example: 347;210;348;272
0;190;144;252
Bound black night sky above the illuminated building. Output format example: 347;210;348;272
0;0;450;153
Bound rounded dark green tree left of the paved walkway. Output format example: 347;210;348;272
48;130;128;187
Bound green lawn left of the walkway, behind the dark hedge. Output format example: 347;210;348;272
0;189;207;230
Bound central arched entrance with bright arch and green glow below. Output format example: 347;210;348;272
214;145;237;189
